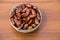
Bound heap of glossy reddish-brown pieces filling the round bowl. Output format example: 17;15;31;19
10;4;41;30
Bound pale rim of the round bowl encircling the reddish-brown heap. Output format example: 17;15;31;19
9;3;42;33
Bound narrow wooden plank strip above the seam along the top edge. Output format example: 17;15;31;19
0;0;60;3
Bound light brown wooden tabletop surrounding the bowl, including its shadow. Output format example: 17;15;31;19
0;0;60;40
